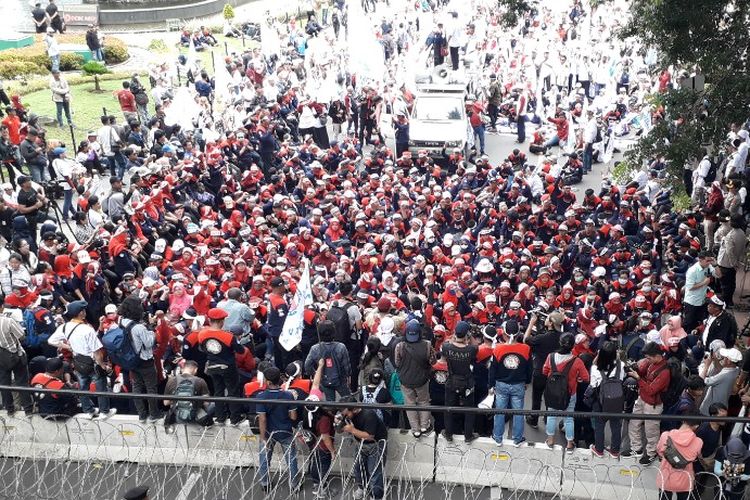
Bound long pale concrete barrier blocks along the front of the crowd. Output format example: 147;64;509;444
0;414;658;500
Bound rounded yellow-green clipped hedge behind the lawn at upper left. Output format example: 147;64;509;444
0;34;129;79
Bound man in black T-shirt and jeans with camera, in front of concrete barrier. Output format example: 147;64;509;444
335;396;388;500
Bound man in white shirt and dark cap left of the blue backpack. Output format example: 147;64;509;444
47;300;117;418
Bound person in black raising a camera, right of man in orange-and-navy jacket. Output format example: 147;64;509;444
523;311;563;429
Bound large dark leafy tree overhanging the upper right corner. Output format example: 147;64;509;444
620;0;750;173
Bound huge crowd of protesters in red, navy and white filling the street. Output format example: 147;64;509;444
0;0;750;498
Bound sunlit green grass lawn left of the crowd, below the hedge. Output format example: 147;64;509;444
21;77;131;145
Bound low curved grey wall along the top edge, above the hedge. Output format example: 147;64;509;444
99;0;262;26
